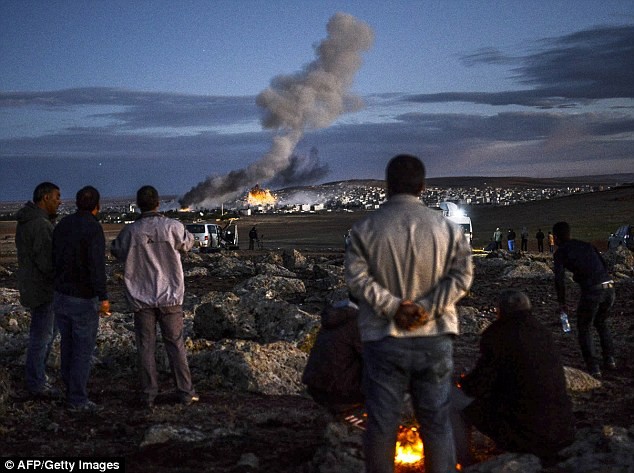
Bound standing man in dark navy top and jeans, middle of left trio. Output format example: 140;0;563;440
53;186;110;412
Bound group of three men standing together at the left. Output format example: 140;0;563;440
16;182;198;411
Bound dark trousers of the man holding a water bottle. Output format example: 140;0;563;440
577;288;615;369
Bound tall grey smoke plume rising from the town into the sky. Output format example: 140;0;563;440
179;13;374;207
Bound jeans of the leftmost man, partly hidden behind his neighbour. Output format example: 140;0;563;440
26;303;57;393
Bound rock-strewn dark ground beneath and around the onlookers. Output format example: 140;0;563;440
0;245;634;473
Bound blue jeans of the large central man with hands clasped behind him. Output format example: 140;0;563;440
363;335;456;473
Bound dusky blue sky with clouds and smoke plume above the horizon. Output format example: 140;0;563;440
0;0;634;206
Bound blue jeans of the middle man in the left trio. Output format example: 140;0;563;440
54;292;99;406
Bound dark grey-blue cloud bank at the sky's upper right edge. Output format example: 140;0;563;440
409;25;634;108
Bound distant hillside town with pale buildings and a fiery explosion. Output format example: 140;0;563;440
0;174;634;223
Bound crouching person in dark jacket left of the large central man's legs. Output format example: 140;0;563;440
302;299;363;415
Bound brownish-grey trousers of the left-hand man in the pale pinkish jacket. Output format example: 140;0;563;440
134;306;195;400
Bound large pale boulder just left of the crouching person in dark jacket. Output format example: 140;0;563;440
190;340;307;395
